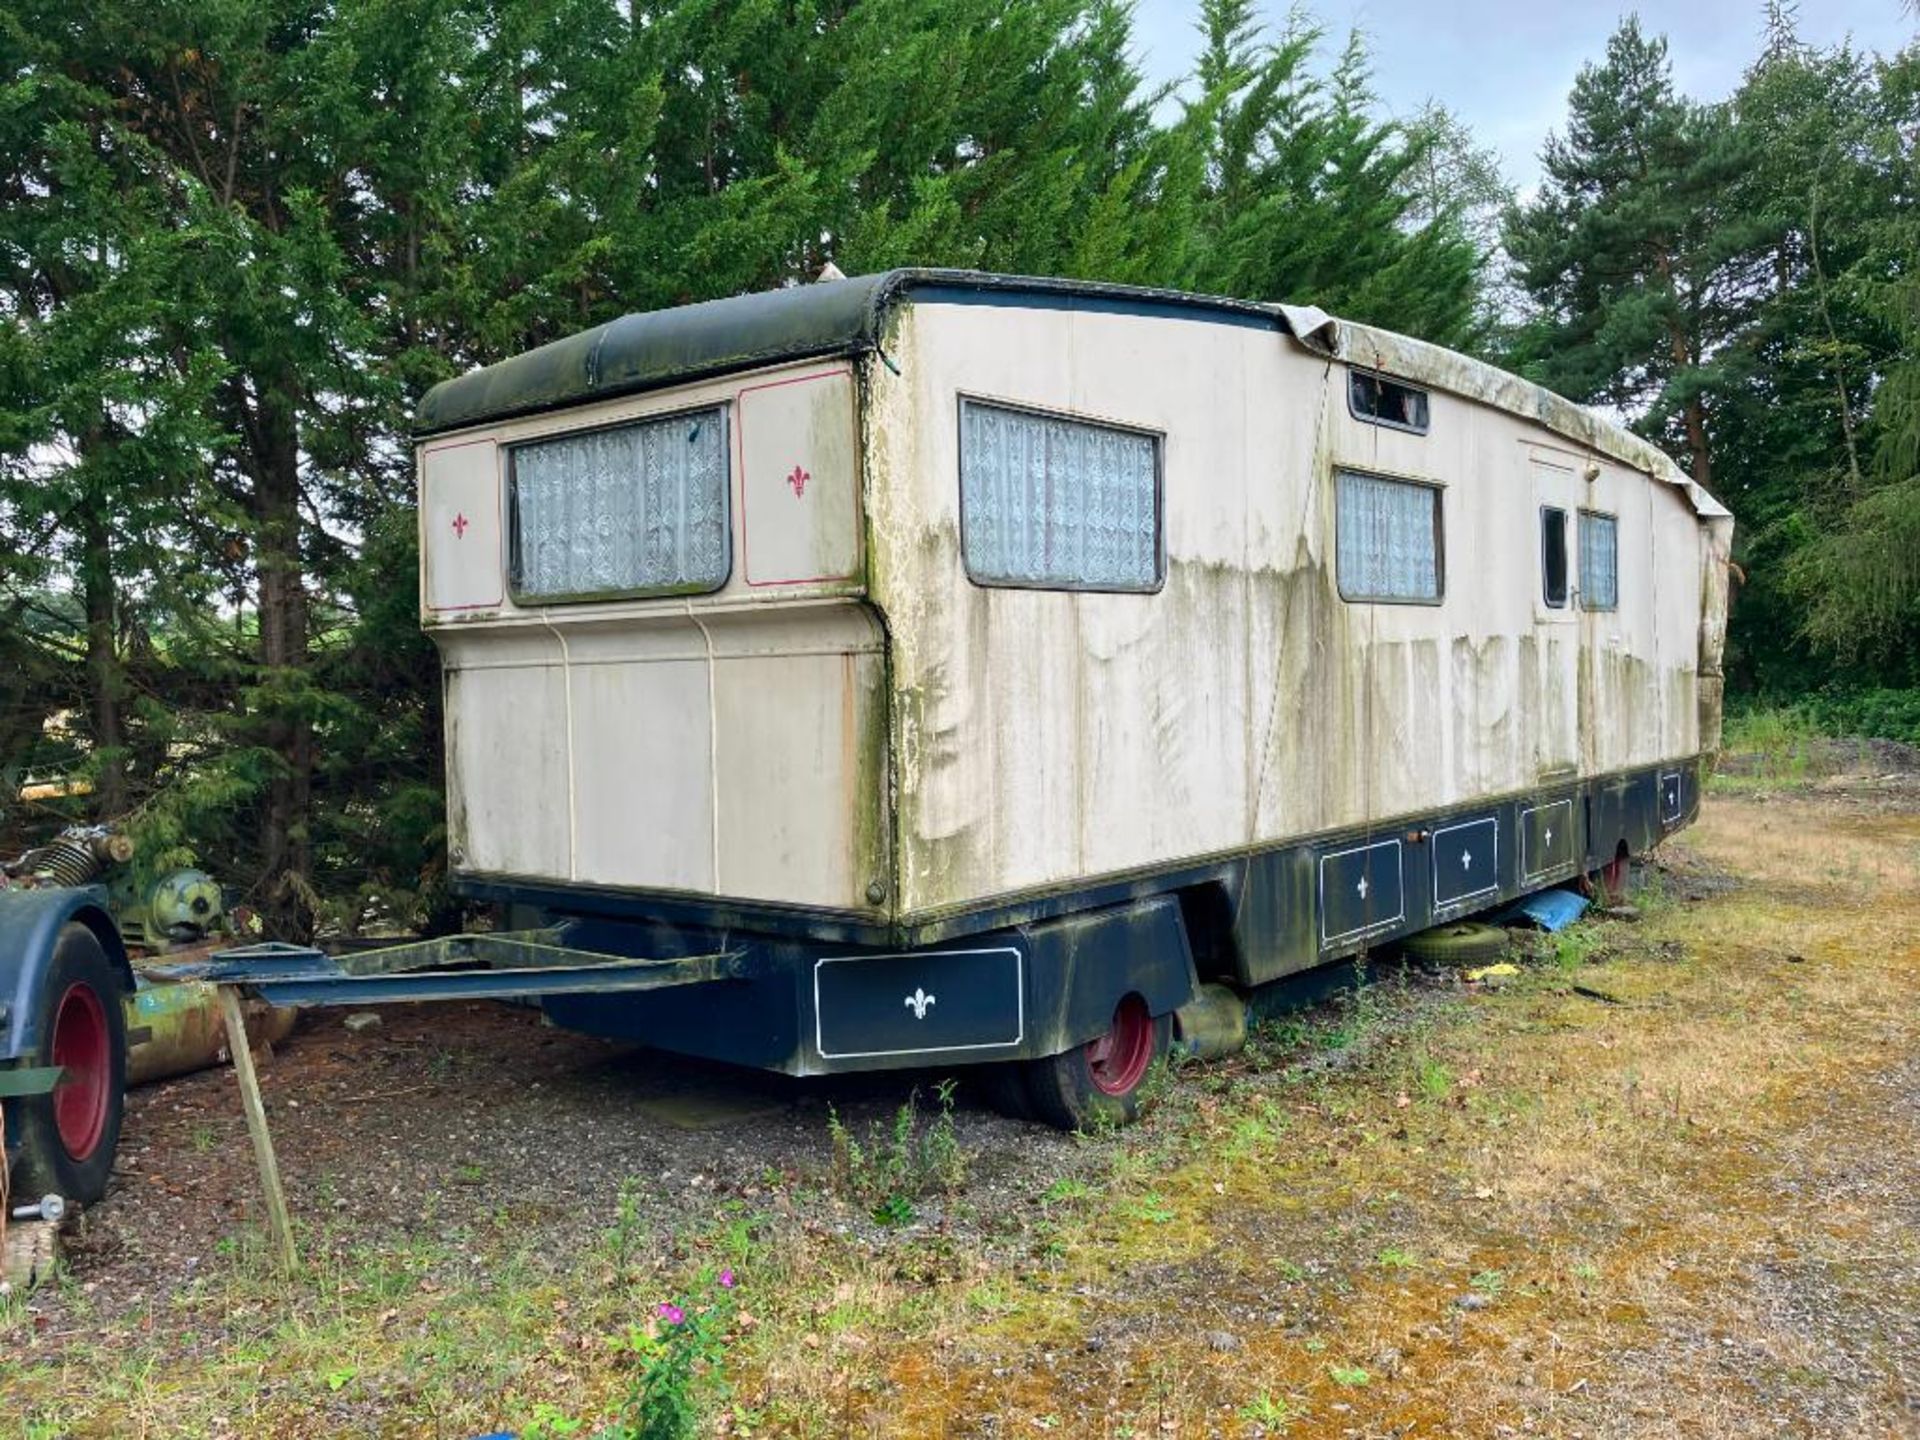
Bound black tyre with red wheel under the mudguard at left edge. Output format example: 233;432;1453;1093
8;924;127;1204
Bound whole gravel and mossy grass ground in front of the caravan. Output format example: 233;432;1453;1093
0;778;1920;1436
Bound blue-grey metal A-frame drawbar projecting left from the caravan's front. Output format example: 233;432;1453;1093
148;925;749;1006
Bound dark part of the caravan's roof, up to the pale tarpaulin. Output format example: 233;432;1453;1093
413;269;1288;436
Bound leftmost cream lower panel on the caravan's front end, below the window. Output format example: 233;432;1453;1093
442;632;574;879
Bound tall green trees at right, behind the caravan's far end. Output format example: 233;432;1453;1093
1505;19;1920;726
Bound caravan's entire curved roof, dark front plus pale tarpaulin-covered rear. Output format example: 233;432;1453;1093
415;269;1728;518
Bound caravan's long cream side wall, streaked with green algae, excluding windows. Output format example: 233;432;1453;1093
866;296;1724;948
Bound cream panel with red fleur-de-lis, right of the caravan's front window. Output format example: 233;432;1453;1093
735;369;860;586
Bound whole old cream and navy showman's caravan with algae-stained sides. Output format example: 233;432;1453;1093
382;271;1732;1125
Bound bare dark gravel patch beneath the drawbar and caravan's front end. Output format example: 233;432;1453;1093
63;1002;1089;1327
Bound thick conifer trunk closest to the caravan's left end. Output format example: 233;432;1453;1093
253;382;313;939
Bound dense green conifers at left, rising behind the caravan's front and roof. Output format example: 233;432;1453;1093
0;0;1498;935
